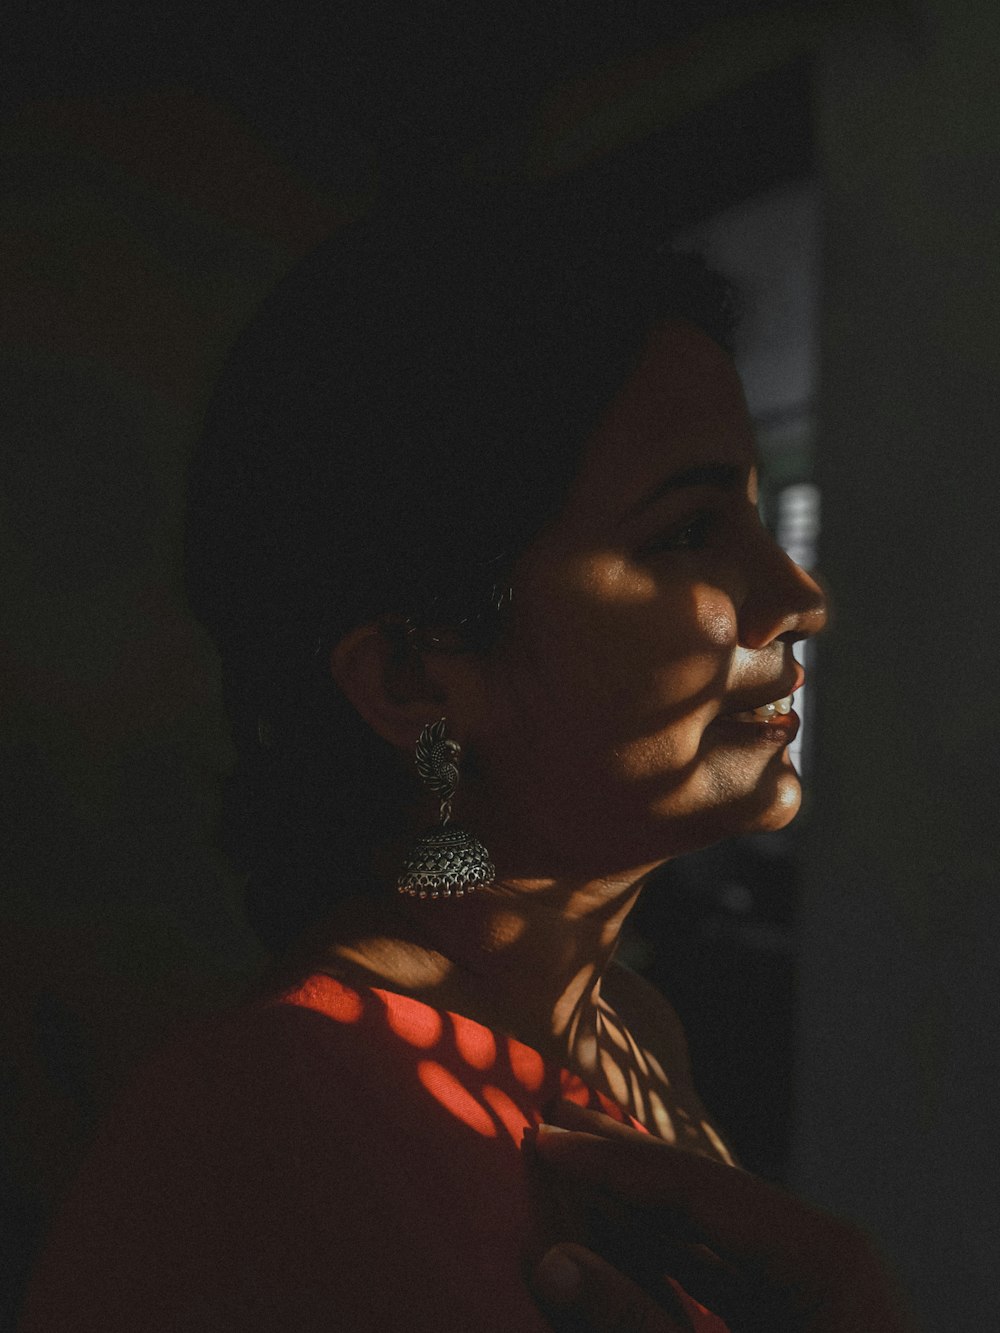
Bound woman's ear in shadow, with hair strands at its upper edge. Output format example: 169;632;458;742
329;624;477;753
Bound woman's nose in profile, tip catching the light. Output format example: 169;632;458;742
739;532;827;648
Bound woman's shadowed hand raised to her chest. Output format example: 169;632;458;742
533;1102;912;1333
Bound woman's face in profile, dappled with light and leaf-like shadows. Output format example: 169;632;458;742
461;321;825;876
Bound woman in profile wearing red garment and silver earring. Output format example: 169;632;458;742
17;182;917;1333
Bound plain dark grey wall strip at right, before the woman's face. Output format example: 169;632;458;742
793;0;1000;1333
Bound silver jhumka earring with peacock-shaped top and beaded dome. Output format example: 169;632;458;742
397;717;496;898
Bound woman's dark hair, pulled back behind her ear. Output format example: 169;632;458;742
185;188;736;950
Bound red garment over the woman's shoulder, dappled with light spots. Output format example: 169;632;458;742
20;976;725;1333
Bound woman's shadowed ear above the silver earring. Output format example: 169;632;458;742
329;624;444;750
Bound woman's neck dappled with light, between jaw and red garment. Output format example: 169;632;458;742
285;866;649;1064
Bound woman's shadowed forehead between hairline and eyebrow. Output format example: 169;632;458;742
565;320;756;525
